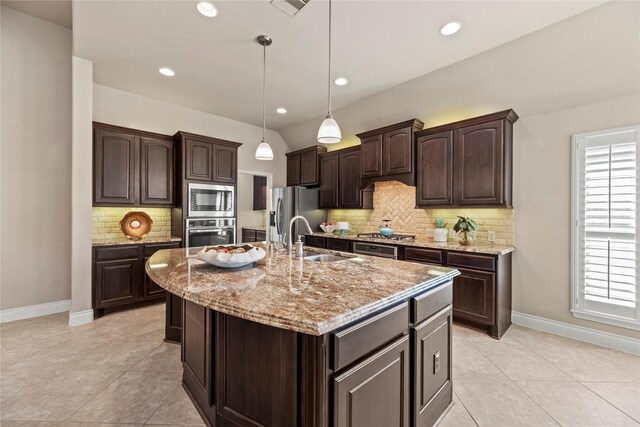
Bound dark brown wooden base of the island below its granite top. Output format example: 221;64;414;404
182;278;452;427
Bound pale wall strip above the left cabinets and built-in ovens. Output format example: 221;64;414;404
93;84;289;187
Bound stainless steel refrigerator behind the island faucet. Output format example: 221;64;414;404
269;187;327;243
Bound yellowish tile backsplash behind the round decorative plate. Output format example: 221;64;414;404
91;207;171;239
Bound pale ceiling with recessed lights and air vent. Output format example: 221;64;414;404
73;0;602;130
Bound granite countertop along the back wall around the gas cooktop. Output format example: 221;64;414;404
313;233;516;255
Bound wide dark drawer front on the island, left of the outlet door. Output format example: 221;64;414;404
331;303;409;371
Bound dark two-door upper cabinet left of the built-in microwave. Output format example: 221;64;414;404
93;123;174;206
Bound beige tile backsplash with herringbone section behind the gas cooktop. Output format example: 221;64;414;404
329;181;513;245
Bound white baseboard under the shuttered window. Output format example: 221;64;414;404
511;311;640;355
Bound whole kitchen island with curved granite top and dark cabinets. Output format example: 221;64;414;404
146;244;459;426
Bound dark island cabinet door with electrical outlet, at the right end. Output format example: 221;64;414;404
412;306;453;427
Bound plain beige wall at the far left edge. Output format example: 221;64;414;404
0;6;71;310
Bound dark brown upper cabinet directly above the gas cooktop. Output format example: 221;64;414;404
357;119;424;187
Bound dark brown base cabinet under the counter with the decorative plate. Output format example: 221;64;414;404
92;242;180;317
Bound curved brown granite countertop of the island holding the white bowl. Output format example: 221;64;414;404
145;243;460;335
